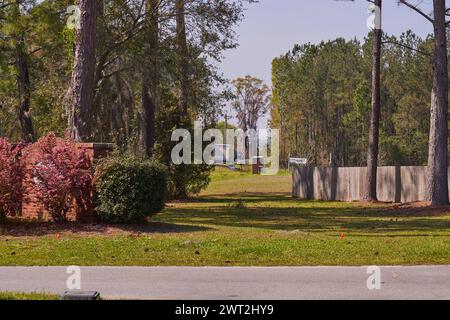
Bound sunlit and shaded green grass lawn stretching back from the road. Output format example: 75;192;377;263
0;170;450;266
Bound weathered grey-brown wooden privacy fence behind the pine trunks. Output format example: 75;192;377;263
292;166;450;203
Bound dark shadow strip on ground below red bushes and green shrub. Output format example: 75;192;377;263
0;220;213;237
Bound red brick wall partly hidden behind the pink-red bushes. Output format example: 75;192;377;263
21;143;113;222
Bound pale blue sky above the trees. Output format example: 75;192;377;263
220;0;433;127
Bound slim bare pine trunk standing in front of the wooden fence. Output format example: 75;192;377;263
364;0;383;201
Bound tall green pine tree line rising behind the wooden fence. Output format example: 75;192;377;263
271;31;446;166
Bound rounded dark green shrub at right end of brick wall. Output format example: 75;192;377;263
95;155;167;223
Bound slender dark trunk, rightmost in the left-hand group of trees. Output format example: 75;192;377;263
176;0;189;117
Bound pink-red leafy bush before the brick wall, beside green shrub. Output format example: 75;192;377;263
30;134;94;222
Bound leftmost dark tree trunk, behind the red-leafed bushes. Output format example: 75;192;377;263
16;39;35;142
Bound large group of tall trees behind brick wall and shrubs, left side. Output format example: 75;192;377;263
0;0;253;197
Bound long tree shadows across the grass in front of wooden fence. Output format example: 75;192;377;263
162;194;450;236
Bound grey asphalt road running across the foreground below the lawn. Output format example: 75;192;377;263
0;266;450;300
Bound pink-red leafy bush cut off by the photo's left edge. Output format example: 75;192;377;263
0;139;25;222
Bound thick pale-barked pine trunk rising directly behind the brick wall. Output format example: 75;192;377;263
67;0;98;141
